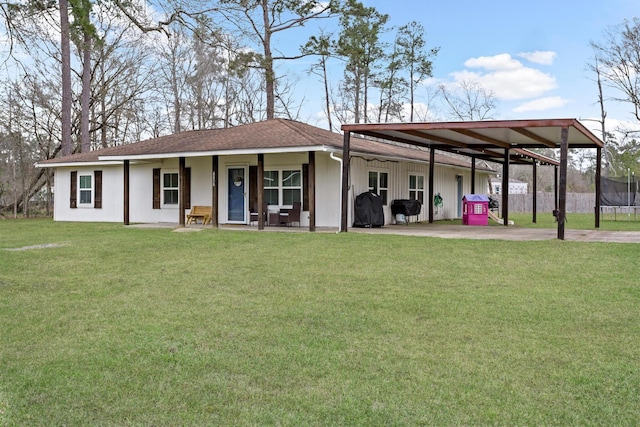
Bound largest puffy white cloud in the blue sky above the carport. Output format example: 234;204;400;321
452;53;557;100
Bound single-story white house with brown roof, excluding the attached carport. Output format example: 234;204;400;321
37;119;494;230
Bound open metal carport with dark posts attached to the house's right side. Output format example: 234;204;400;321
340;119;604;240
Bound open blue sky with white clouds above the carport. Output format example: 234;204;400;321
284;0;640;135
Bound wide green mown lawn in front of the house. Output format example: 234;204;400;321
0;217;640;426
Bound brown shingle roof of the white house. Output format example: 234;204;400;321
39;119;490;171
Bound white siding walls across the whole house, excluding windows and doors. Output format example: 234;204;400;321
54;152;487;227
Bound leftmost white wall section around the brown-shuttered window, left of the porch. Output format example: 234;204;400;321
53;165;124;222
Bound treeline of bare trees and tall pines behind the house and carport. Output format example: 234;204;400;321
0;0;640;216
